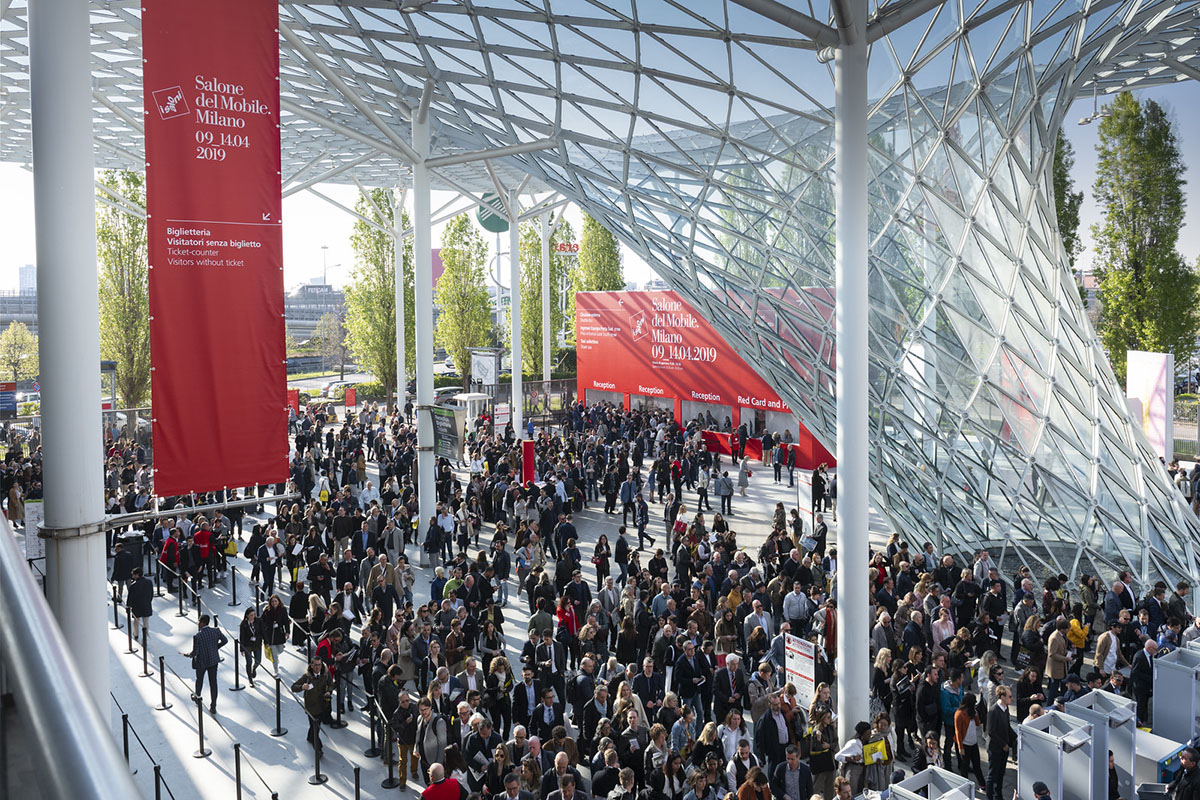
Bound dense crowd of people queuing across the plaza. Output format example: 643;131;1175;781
14;395;1200;800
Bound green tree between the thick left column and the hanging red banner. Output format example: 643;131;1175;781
96;169;150;408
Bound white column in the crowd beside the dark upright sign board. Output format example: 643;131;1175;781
413;115;437;527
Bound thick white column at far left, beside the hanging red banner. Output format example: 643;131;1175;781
29;0;109;720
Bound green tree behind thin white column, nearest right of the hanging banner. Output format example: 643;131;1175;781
343;188;415;408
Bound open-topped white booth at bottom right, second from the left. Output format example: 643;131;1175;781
1016;711;1108;800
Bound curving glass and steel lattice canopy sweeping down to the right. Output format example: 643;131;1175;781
0;0;1200;581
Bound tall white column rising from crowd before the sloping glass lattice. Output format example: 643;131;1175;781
834;0;871;741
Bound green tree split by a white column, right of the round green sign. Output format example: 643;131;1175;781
516;214;575;377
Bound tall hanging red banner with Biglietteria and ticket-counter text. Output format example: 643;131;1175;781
142;0;288;495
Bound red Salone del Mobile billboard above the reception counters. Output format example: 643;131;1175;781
575;291;791;414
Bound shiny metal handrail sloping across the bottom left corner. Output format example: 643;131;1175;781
0;517;142;800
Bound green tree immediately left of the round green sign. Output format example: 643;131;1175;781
433;213;492;389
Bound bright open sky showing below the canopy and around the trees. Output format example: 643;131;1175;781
0;82;1200;289
